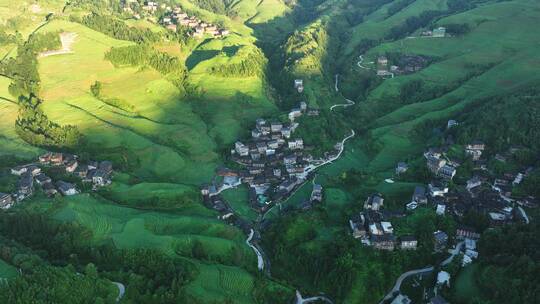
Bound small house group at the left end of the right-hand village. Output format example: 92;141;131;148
349;194;418;250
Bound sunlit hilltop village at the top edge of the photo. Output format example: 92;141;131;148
122;0;230;38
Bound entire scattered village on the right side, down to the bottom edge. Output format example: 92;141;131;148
349;120;538;304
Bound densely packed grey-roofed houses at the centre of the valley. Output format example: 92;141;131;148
202;102;330;211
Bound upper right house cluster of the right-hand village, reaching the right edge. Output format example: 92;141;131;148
410;134;537;226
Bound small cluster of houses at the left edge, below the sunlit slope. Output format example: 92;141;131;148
0;152;112;209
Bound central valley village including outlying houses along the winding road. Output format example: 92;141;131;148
197;79;346;231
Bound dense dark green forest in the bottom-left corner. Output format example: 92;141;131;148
0;212;194;303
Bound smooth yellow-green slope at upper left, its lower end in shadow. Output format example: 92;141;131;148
35;21;216;183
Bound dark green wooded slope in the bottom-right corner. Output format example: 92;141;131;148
442;223;539;303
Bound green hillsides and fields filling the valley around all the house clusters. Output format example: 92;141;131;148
0;0;540;304
